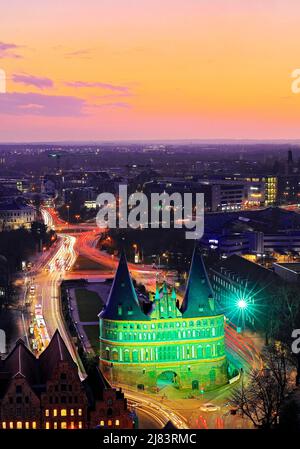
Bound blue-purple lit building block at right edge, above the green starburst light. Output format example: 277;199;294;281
201;207;300;258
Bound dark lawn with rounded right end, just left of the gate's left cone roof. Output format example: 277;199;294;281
75;288;103;321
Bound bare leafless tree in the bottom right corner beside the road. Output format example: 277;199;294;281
231;343;293;429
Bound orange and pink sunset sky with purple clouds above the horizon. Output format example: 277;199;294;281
0;0;300;142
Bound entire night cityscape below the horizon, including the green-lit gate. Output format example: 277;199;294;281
0;144;300;431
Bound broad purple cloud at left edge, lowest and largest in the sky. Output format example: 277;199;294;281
0;92;88;117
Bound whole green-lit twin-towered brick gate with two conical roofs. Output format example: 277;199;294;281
100;247;228;389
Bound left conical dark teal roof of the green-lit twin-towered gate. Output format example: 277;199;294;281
99;250;150;321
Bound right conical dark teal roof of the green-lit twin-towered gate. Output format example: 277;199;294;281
181;248;220;318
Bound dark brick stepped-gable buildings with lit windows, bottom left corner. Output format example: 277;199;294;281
0;331;133;429
